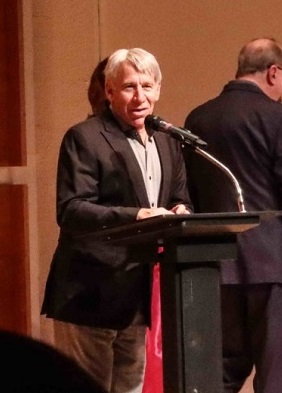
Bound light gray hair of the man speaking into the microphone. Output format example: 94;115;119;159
104;48;162;83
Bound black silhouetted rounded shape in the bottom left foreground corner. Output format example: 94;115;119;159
0;330;107;393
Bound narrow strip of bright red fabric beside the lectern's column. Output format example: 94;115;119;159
142;264;163;393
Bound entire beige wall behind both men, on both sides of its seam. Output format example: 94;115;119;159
22;0;282;388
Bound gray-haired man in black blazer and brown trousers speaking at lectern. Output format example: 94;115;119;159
42;48;192;393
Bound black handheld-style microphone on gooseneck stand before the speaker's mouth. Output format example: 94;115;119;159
145;115;208;148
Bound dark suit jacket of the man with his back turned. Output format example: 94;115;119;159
185;81;282;283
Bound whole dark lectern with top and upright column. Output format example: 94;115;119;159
92;212;262;393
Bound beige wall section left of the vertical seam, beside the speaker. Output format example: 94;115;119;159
32;0;99;340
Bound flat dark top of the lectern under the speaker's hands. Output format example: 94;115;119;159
80;211;282;243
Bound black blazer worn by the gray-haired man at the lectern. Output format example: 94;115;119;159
42;111;191;329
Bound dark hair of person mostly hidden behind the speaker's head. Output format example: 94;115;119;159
88;57;108;115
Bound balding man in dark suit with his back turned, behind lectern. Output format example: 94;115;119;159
185;38;282;393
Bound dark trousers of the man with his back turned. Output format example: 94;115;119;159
221;284;282;393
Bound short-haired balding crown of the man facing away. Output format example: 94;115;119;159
236;38;282;79
